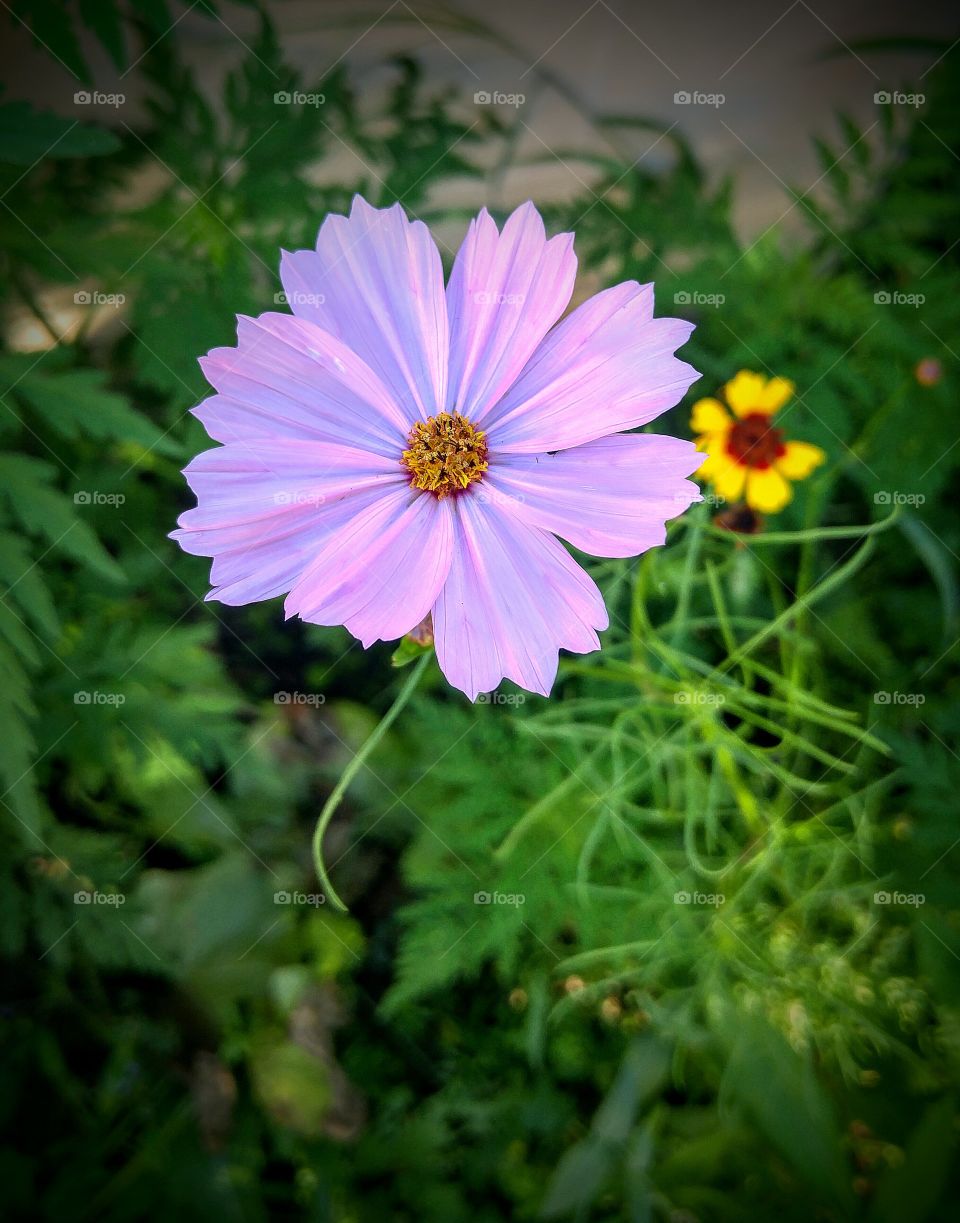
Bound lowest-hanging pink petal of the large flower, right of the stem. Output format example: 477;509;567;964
433;497;609;701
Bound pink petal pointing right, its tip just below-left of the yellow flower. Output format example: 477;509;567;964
486;433;703;556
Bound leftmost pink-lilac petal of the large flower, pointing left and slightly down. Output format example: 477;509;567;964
171;438;407;605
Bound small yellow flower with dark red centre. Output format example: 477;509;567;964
690;369;827;514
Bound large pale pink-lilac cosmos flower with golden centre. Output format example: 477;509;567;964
172;197;701;700
